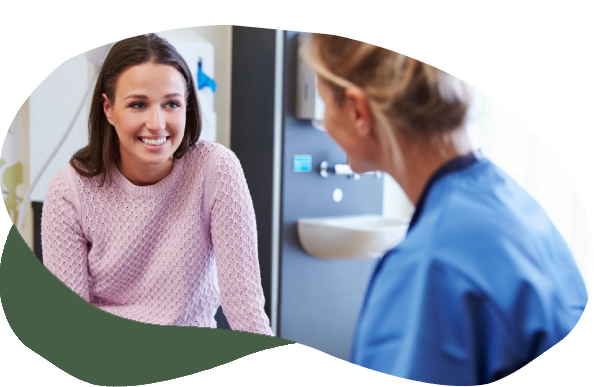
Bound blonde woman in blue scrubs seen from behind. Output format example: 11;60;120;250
301;33;588;386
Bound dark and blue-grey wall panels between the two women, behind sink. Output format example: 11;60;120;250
231;26;386;367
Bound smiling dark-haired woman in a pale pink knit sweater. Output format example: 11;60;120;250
41;34;273;335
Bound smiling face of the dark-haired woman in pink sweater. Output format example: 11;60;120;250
103;62;186;174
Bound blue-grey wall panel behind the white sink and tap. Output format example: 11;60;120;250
280;31;383;367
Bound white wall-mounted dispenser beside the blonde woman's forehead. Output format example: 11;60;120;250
295;33;325;131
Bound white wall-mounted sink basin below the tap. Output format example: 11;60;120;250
297;215;409;259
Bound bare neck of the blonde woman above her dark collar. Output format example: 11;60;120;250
387;128;472;207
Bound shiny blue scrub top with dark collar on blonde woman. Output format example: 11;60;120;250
351;154;588;386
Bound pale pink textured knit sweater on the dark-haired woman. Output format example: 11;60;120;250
41;140;273;336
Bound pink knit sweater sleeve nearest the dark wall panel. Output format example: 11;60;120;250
211;149;274;336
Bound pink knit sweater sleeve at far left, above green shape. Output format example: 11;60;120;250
41;169;90;302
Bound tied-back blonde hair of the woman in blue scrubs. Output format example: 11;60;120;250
300;32;468;182
